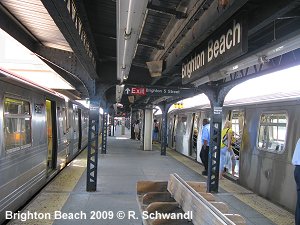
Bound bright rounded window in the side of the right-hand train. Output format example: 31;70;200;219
258;113;287;153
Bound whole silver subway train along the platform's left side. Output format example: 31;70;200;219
0;69;89;224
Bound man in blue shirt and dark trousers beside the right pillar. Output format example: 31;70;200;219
200;119;210;176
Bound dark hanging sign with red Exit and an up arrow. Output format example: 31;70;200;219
123;85;193;96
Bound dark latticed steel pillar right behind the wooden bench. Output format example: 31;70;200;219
204;86;233;192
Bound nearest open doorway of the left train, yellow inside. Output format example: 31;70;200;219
46;100;57;173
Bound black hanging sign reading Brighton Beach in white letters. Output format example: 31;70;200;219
181;16;248;84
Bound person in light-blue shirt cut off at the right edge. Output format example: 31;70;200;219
292;138;300;225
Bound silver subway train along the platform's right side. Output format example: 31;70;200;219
155;91;300;212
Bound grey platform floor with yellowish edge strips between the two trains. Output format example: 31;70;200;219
8;127;294;225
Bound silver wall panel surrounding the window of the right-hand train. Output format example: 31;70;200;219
239;101;300;210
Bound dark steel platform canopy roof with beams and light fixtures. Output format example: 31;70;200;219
0;0;300;111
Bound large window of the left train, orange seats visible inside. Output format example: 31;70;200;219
4;98;31;152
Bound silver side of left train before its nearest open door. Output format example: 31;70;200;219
0;81;54;221
